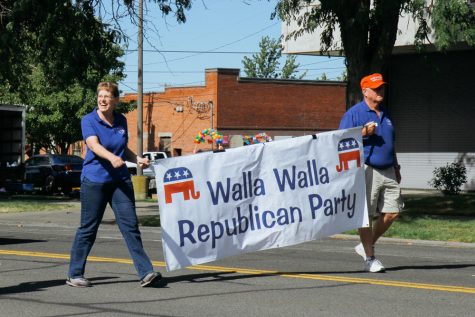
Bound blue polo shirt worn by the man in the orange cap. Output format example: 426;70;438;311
340;100;395;169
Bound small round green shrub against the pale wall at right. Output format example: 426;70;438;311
429;162;467;195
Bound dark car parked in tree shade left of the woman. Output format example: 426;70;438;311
25;154;84;194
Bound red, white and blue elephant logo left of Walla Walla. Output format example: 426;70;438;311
163;167;200;204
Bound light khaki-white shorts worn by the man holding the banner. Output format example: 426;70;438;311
365;165;404;217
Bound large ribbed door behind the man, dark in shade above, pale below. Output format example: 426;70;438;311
387;51;475;190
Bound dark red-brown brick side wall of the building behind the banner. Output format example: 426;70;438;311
218;69;346;135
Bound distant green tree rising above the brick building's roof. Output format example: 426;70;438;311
242;36;305;79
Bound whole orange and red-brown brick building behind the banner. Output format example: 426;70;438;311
123;68;346;156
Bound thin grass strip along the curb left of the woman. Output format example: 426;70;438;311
0;195;79;213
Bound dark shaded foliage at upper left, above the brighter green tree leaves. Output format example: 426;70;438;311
0;0;122;88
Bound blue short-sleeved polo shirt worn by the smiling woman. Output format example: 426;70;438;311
81;109;130;183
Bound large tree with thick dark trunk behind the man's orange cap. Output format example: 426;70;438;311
275;0;475;105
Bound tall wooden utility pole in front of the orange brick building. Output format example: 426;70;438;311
137;0;143;176
